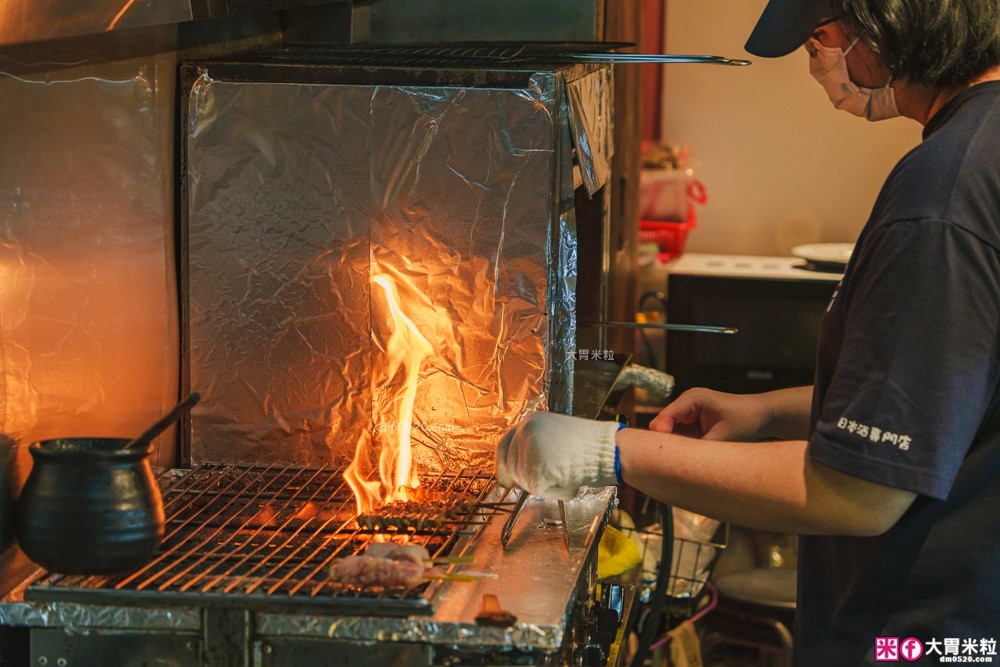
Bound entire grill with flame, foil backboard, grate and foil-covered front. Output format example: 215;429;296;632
0;48;615;666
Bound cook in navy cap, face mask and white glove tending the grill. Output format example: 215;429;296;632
496;0;1000;667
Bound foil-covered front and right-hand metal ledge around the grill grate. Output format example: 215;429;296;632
0;487;616;667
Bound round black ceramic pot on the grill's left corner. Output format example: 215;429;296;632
16;438;164;574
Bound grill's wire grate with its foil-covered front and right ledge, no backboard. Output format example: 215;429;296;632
0;464;615;667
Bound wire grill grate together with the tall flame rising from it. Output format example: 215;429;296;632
30;273;502;613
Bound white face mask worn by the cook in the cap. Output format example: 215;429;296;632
809;37;899;120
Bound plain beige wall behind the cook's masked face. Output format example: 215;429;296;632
661;0;921;255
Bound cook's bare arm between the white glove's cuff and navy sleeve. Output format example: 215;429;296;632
617;429;913;535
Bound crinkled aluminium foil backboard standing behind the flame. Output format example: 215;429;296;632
185;65;607;470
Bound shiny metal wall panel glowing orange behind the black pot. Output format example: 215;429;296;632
0;29;180;472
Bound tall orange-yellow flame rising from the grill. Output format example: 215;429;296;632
344;273;434;514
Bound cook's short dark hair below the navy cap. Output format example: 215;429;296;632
831;0;1000;87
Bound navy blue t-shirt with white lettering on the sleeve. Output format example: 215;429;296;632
796;82;1000;667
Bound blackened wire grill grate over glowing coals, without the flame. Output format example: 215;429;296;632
25;464;500;615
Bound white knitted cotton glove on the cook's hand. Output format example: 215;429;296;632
496;412;618;500
